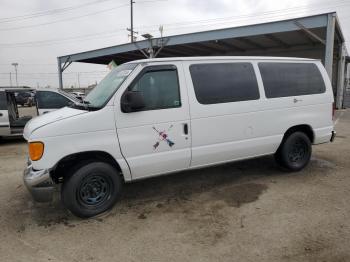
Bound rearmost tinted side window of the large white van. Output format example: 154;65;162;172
259;63;326;98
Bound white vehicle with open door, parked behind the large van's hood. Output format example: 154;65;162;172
0;88;77;138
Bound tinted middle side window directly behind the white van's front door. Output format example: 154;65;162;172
190;63;260;105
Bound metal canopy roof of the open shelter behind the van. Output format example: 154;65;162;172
58;13;343;64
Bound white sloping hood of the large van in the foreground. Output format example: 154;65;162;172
23;107;88;140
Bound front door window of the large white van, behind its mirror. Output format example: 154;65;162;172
129;69;181;111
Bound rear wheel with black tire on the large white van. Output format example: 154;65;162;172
275;132;312;171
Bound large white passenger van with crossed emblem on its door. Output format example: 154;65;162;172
24;57;335;217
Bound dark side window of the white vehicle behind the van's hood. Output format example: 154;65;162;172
36;91;71;109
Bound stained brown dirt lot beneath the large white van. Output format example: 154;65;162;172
0;111;350;262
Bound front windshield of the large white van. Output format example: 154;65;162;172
84;64;138;108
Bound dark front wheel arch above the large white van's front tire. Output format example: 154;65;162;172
50;151;124;183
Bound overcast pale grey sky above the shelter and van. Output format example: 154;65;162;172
0;0;350;87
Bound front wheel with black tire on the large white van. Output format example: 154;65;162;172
61;162;123;218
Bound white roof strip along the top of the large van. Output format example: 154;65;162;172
127;56;318;64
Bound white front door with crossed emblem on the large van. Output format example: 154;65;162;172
115;62;191;179
